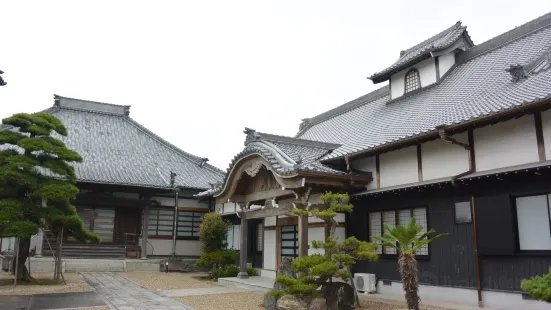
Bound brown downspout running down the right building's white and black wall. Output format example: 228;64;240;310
438;127;484;308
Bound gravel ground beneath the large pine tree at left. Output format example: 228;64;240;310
0;272;90;295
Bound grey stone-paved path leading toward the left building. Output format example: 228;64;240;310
80;272;193;310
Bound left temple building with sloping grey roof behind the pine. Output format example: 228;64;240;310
0;95;224;258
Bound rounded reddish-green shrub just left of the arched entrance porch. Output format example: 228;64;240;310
199;212;231;253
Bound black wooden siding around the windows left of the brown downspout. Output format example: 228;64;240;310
354;188;476;288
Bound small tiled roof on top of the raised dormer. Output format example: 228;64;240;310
370;22;473;83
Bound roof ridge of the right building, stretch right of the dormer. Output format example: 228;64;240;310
457;12;551;65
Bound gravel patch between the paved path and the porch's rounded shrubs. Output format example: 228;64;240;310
120;271;216;290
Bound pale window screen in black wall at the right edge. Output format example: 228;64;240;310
516;195;551;250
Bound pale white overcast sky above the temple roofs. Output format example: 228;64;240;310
0;0;551;170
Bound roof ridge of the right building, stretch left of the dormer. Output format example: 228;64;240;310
295;85;390;139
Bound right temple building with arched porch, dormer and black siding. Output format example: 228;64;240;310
198;13;551;309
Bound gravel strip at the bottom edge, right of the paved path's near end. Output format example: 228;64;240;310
174;292;264;310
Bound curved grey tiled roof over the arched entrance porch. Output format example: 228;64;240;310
197;128;349;197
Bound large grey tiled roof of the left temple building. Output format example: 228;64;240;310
2;96;224;189
